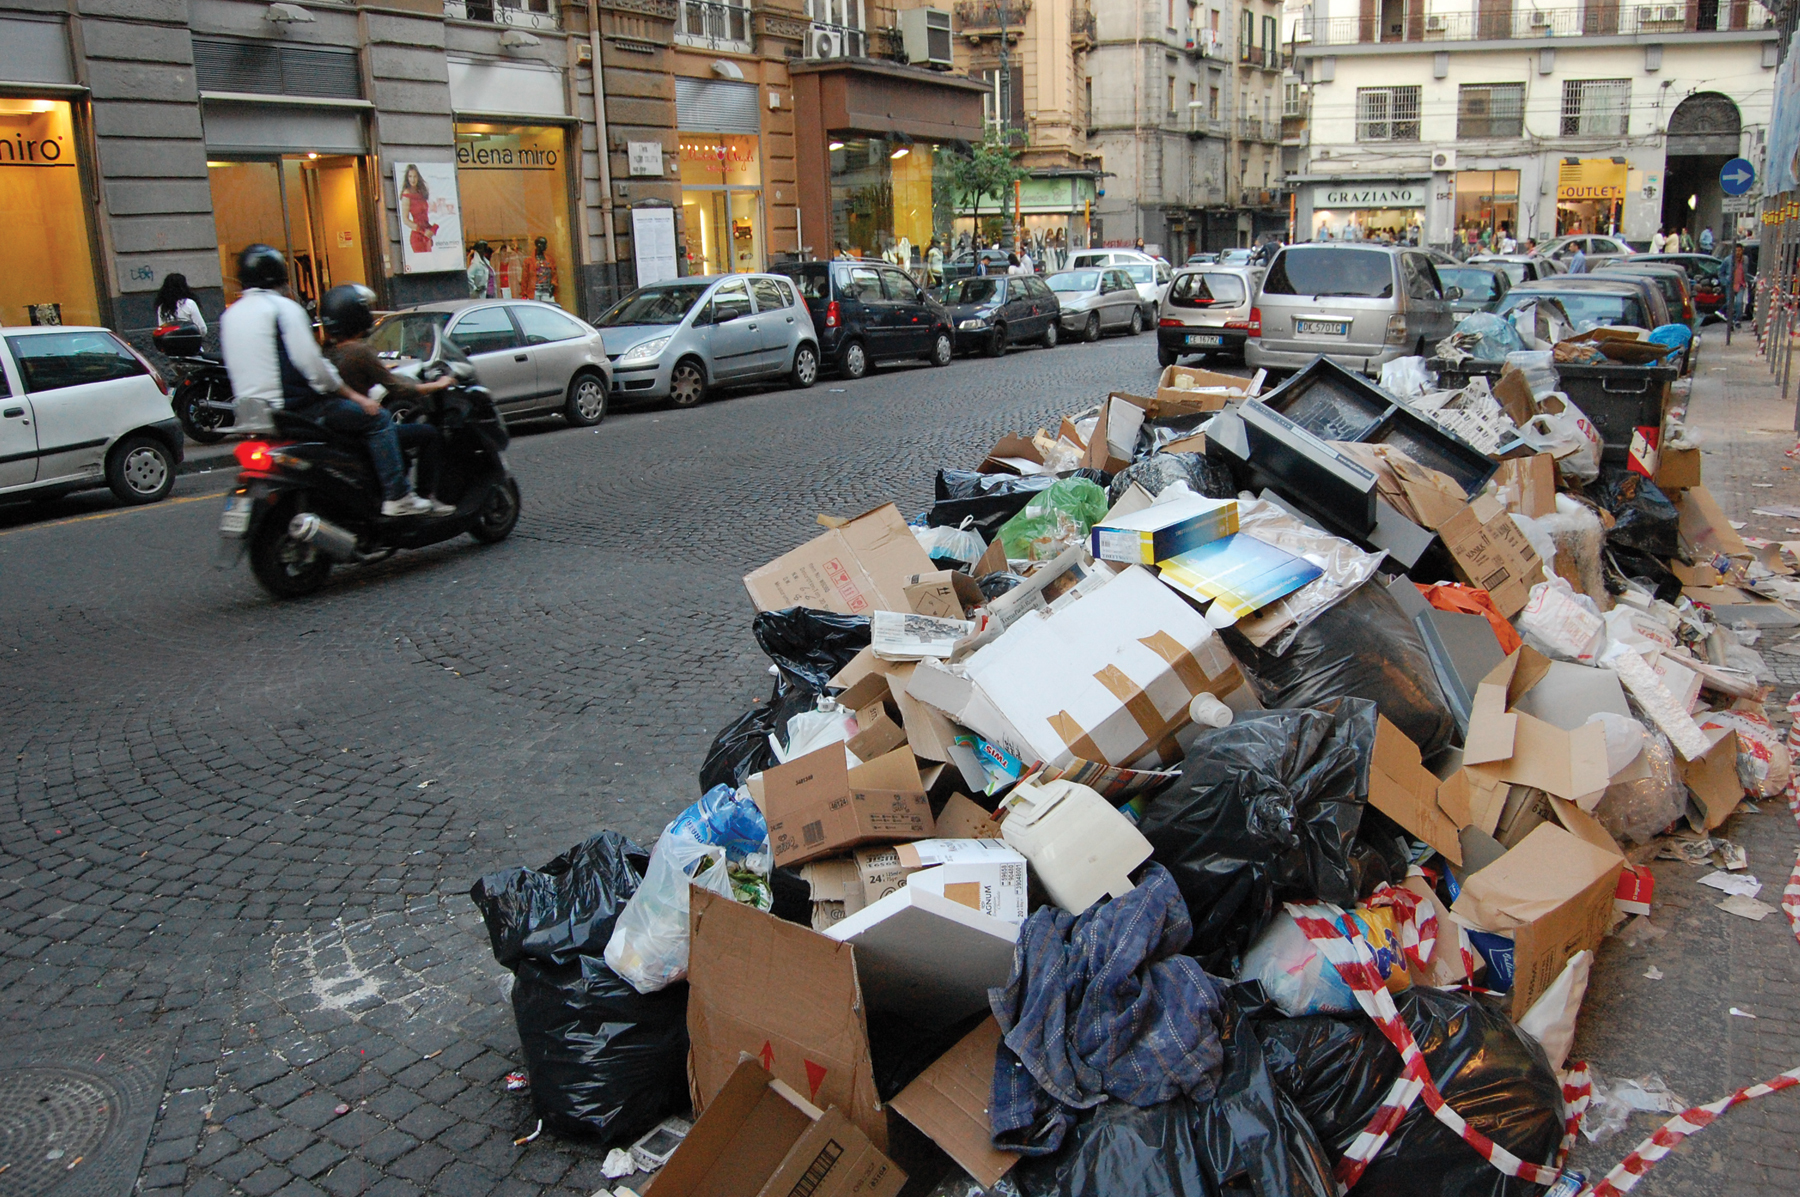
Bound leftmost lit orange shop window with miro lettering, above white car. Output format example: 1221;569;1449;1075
0;99;101;324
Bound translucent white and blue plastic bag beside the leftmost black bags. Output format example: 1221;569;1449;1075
607;787;774;994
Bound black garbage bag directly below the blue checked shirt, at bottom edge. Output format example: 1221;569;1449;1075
1008;1098;1213;1197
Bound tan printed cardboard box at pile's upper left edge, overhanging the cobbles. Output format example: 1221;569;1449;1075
743;502;934;616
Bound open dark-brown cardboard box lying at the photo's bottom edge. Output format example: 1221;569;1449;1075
646;1060;905;1197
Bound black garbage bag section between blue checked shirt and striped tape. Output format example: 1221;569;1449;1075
1193;981;1337;1197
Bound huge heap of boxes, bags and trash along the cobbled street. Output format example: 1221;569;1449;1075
473;351;1800;1197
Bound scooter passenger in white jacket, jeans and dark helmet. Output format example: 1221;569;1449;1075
220;245;432;517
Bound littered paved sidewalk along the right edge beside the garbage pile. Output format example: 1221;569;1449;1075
1573;326;1800;1197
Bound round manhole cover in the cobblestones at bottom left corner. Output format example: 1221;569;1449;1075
0;1037;169;1197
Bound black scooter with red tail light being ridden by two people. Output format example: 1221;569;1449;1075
220;333;520;598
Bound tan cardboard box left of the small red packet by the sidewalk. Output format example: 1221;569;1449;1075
1451;820;1625;1019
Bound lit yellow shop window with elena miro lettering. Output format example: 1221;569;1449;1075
455;122;574;308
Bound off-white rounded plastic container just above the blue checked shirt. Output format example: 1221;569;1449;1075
1001;781;1150;914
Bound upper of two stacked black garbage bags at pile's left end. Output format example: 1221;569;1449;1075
468;832;650;968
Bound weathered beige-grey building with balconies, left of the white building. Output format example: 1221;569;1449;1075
1084;0;1287;253
